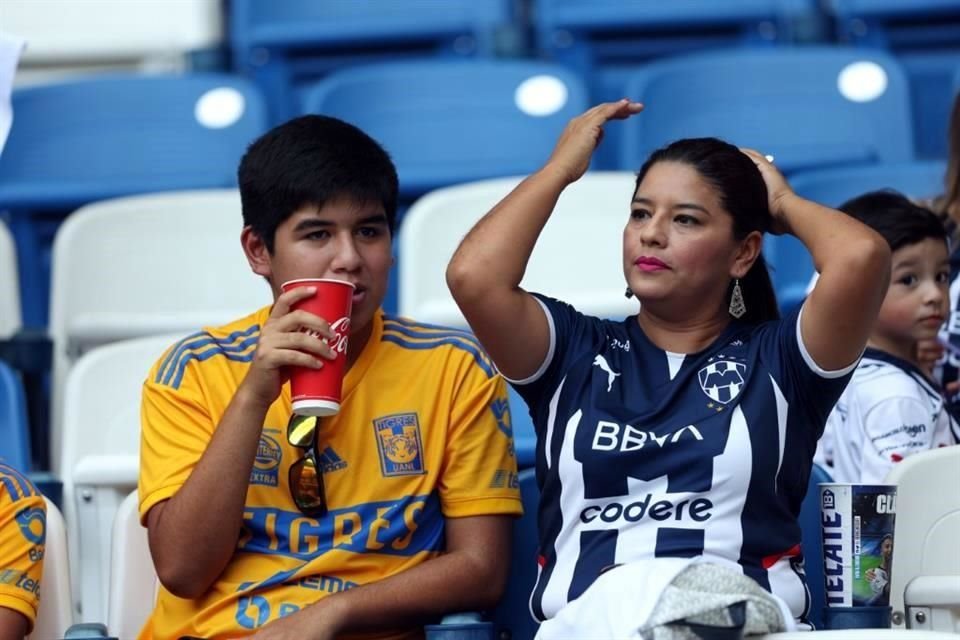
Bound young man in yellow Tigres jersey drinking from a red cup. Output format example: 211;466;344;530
139;116;521;640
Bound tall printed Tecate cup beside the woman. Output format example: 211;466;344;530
820;483;897;607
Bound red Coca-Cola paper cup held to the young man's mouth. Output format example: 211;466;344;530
280;278;354;416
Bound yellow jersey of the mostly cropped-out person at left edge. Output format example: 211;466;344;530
0;460;47;630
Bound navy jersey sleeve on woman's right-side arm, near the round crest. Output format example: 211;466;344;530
759;307;860;443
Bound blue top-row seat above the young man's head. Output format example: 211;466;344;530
229;0;512;121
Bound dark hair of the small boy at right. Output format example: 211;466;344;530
840;189;947;251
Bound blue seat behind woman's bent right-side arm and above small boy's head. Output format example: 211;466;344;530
764;161;946;310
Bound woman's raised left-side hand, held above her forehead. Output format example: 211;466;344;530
545;98;643;184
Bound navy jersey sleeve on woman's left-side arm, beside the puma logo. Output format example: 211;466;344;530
509;293;604;415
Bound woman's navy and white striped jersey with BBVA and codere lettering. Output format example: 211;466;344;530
513;295;854;620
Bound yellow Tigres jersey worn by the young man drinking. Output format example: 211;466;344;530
139;307;521;640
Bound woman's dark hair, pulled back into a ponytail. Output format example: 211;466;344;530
634;138;780;324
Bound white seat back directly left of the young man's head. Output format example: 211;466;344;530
50;189;272;473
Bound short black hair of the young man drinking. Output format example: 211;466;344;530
237;115;397;253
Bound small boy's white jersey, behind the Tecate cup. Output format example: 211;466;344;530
827;349;960;484
